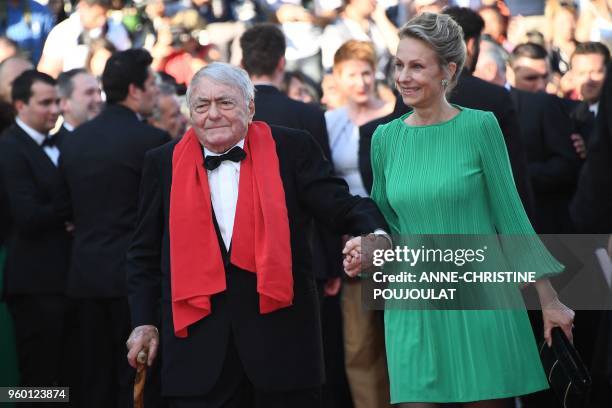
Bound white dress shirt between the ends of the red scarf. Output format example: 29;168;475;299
204;139;244;250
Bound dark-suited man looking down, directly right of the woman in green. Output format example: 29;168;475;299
507;43;580;234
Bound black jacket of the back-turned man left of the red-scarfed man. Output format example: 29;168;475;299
58;105;170;297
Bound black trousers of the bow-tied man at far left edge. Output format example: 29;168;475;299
7;294;77;407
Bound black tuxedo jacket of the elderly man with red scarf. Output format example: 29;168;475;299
128;126;386;396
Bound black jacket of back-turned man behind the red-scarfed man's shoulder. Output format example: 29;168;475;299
254;85;343;280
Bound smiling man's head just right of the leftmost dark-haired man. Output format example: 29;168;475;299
57;68;102;132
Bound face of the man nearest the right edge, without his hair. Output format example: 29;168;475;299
571;54;606;103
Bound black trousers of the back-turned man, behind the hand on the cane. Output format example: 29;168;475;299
77;298;164;408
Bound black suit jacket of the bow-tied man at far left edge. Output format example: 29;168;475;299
0;124;71;295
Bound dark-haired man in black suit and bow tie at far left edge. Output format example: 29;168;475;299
0;70;71;387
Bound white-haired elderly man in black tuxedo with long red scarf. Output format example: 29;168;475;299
128;63;385;408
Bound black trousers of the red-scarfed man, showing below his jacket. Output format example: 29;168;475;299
168;337;321;408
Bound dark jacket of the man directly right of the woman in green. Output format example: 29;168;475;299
510;88;580;234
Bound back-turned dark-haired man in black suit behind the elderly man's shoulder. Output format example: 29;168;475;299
240;23;350;406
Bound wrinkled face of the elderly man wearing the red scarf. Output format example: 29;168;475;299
189;77;255;153
